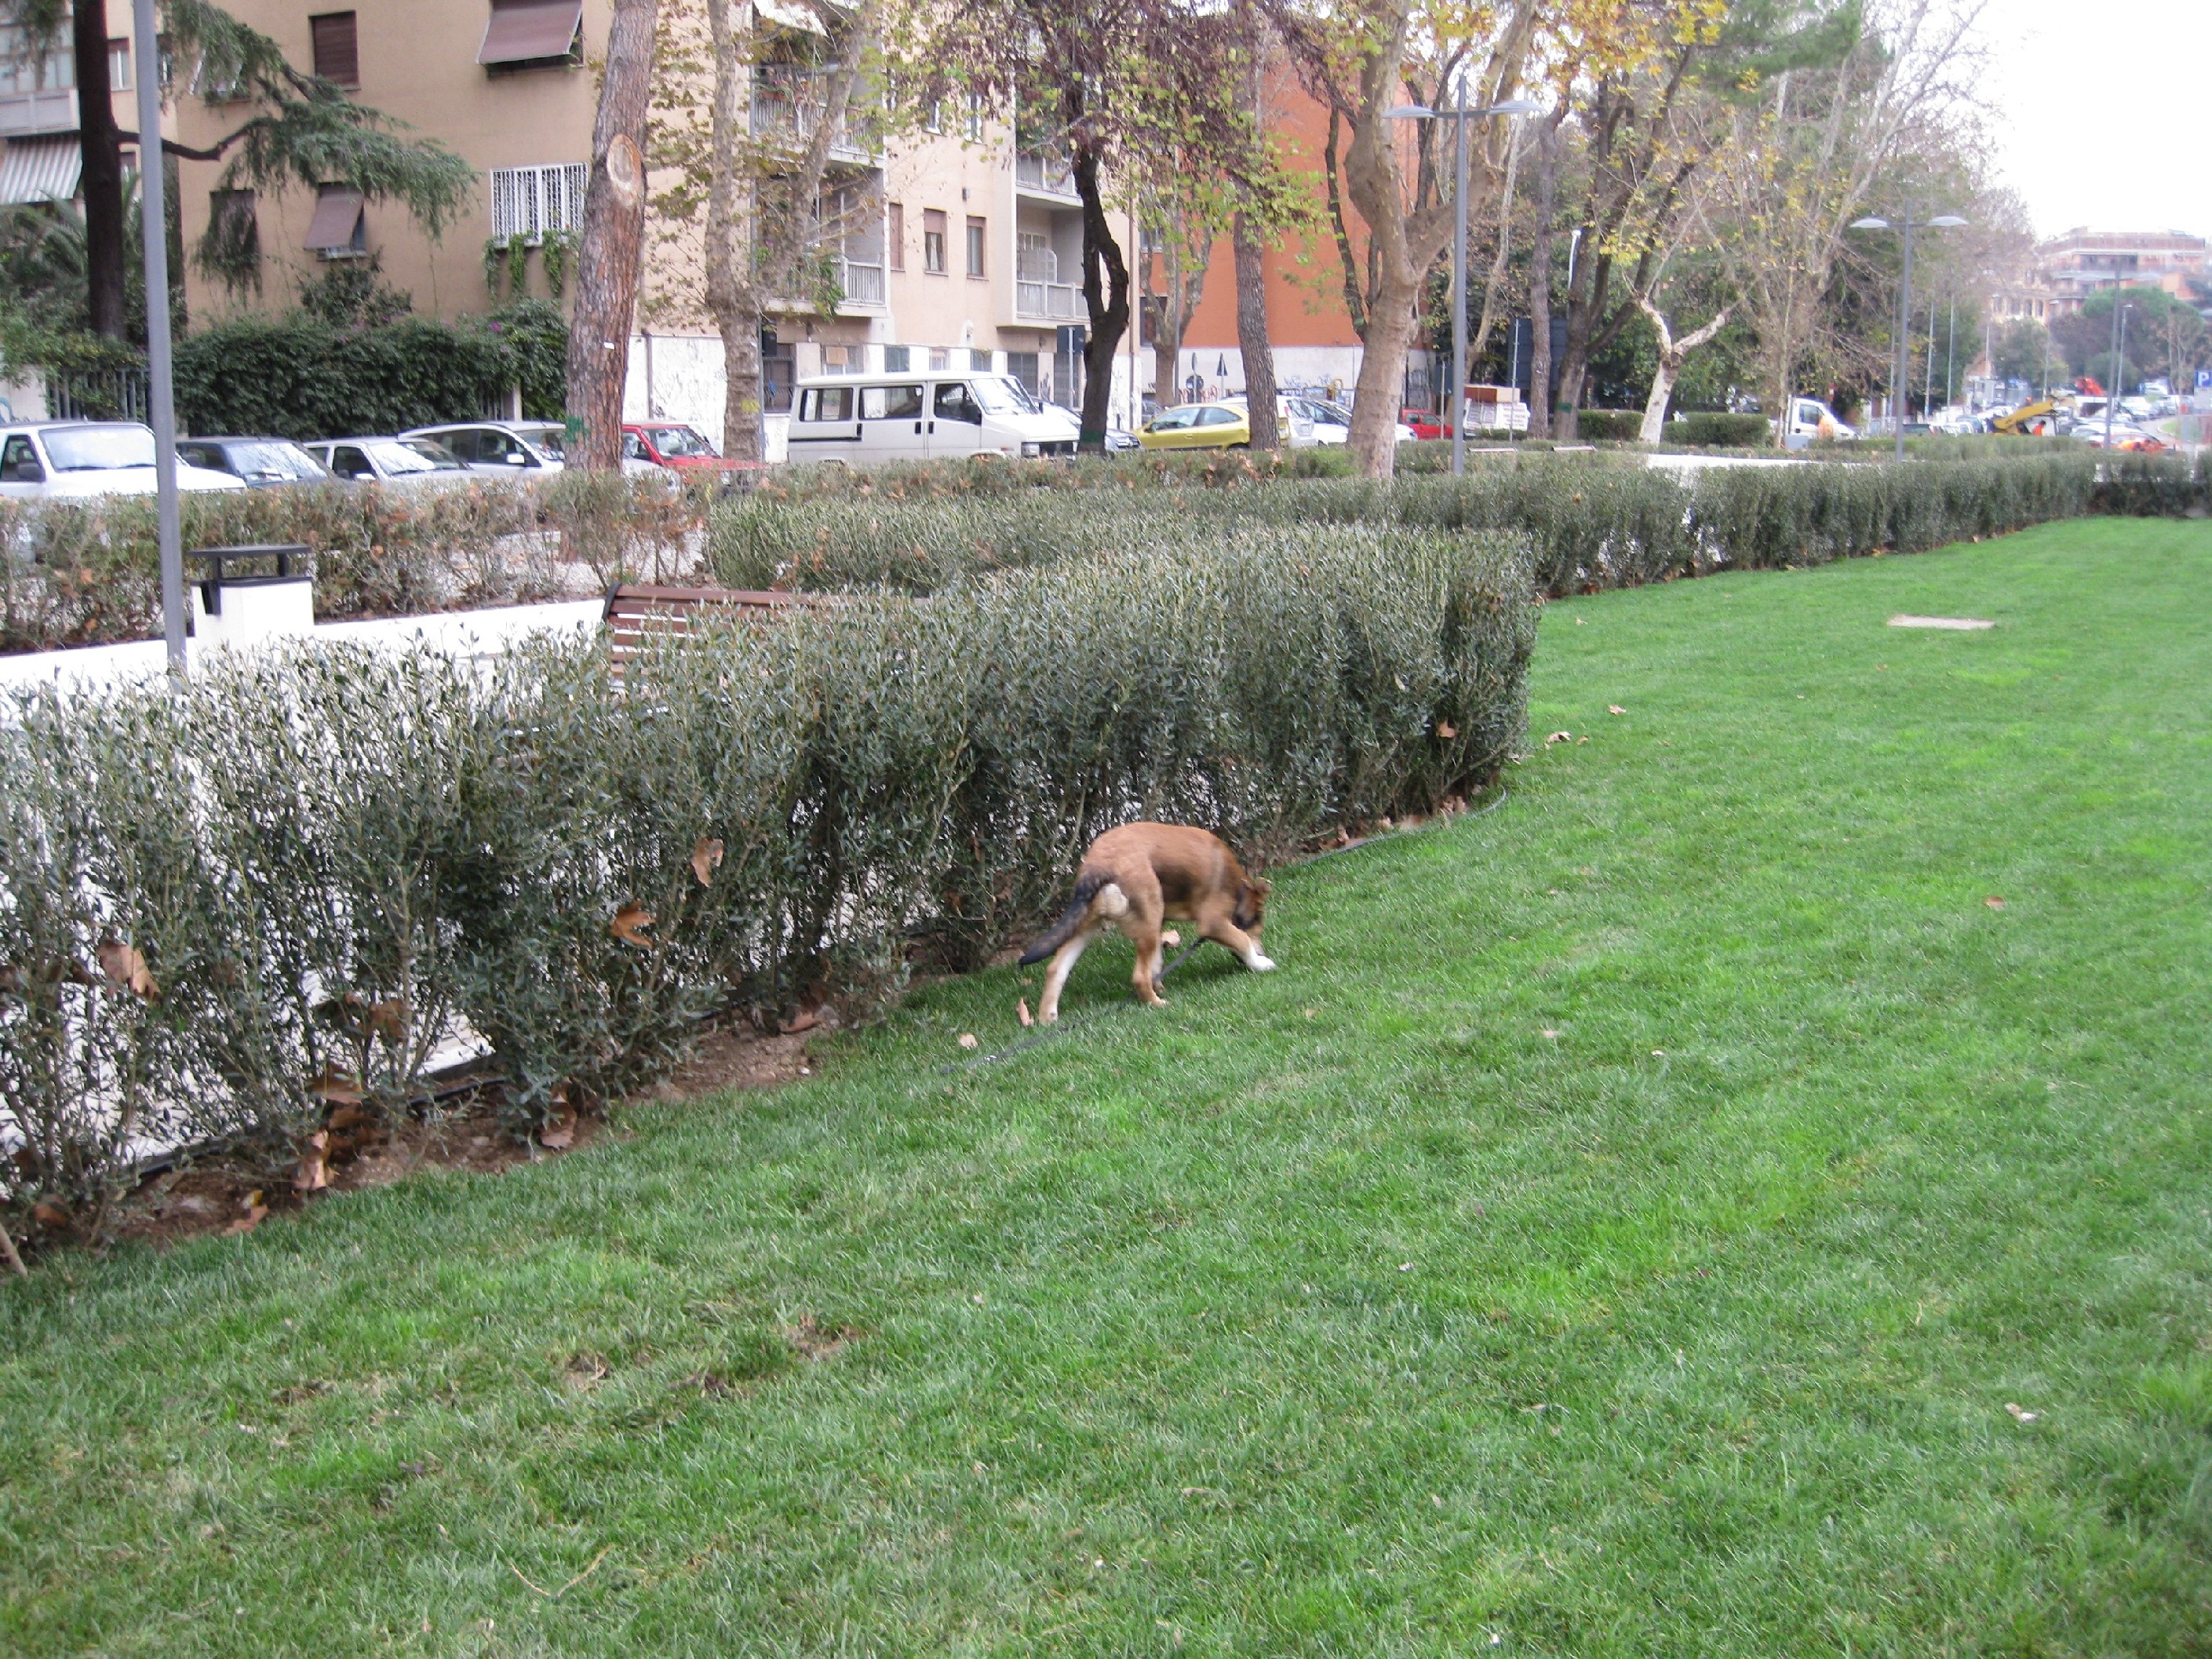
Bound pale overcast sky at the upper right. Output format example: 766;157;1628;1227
1982;0;2212;237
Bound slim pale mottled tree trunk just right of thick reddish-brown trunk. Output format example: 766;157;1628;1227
705;0;761;460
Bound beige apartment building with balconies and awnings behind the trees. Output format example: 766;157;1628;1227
160;0;1137;440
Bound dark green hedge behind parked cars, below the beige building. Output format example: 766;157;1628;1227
177;301;568;438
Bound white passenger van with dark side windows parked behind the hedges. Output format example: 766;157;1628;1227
789;370;1081;465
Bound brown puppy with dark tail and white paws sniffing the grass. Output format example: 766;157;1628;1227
1022;823;1274;1024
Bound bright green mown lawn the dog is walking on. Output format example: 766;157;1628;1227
0;520;2212;1654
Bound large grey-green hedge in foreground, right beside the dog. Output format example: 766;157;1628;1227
0;527;1535;1230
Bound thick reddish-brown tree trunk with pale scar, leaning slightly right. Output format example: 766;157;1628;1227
568;0;659;471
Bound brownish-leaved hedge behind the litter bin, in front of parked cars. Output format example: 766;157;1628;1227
0;473;708;651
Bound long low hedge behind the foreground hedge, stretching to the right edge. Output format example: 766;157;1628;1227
710;451;2212;595
